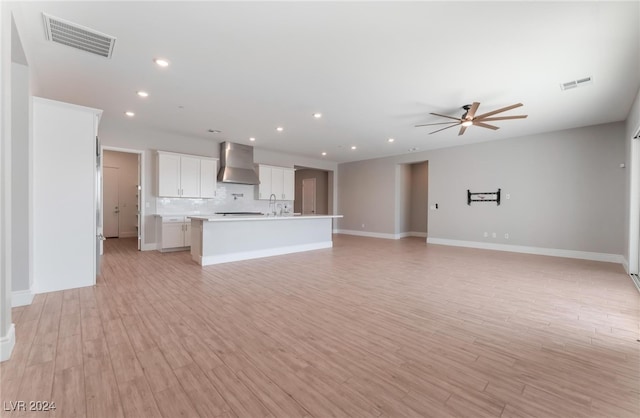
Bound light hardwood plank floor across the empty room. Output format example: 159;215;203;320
0;236;640;418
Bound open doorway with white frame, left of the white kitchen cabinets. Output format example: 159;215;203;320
101;147;144;251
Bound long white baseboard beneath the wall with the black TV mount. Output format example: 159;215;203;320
427;238;624;264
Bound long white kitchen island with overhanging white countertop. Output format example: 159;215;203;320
189;215;342;266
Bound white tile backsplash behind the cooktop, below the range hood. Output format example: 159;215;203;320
156;183;293;215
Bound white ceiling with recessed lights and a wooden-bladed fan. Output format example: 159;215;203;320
12;1;640;162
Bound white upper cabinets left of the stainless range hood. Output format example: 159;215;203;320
158;151;218;198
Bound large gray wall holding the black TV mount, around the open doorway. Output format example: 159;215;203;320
338;123;625;254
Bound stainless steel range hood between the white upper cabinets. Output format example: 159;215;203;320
218;142;260;184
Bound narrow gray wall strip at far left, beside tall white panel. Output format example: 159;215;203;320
11;62;31;292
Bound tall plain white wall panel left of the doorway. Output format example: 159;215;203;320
32;97;99;293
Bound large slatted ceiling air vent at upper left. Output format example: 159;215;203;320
42;13;116;58
